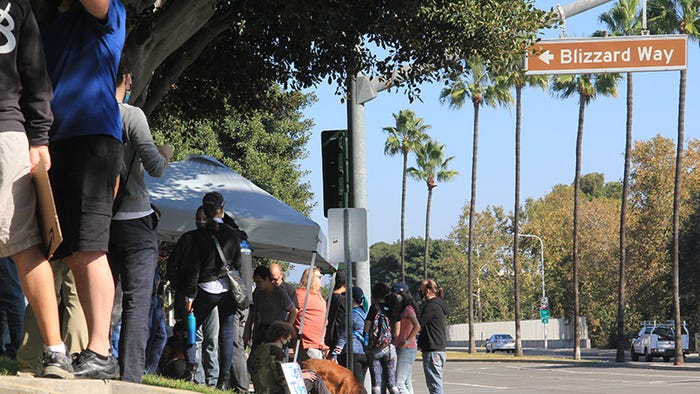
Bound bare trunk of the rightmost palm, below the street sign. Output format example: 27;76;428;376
673;70;687;365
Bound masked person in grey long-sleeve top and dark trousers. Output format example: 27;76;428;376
107;57;173;383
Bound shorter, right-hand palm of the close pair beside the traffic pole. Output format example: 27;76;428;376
408;140;459;280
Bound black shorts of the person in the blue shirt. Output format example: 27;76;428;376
49;135;124;259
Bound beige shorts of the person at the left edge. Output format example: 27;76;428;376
0;131;41;257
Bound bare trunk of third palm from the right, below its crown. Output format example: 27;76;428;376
572;95;586;360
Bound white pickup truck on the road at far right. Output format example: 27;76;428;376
630;320;688;362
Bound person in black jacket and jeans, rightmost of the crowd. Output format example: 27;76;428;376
418;279;447;394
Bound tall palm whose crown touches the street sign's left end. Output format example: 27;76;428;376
507;70;549;356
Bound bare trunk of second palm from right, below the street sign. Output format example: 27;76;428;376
615;73;633;363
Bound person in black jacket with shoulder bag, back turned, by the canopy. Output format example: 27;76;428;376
183;192;241;390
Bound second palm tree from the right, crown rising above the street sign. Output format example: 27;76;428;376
600;0;641;363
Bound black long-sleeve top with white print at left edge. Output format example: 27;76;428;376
0;0;53;146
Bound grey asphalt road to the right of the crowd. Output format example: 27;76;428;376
413;349;700;394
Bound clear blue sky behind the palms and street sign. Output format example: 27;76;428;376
301;0;700;245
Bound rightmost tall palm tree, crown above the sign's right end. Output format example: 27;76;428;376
649;0;700;365
